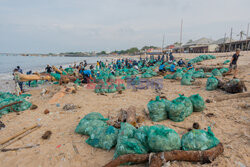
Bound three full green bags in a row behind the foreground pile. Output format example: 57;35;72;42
147;94;205;122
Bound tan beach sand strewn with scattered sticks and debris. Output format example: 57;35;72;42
0;53;250;167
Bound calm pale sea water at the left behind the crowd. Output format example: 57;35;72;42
0;54;107;92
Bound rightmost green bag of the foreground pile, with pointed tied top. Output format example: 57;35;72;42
181;127;220;151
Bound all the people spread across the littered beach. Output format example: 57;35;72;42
13;49;240;94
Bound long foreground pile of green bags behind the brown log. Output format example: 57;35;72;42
75;112;219;160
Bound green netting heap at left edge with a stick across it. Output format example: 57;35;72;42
0;92;32;118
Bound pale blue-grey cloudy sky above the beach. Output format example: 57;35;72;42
0;0;250;53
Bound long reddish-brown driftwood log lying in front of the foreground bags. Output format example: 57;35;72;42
104;143;224;167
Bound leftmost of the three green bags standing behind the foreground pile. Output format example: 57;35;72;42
147;96;168;122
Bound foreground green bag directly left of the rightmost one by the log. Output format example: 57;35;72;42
147;125;181;152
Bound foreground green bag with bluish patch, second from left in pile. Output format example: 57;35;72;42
86;126;119;150
